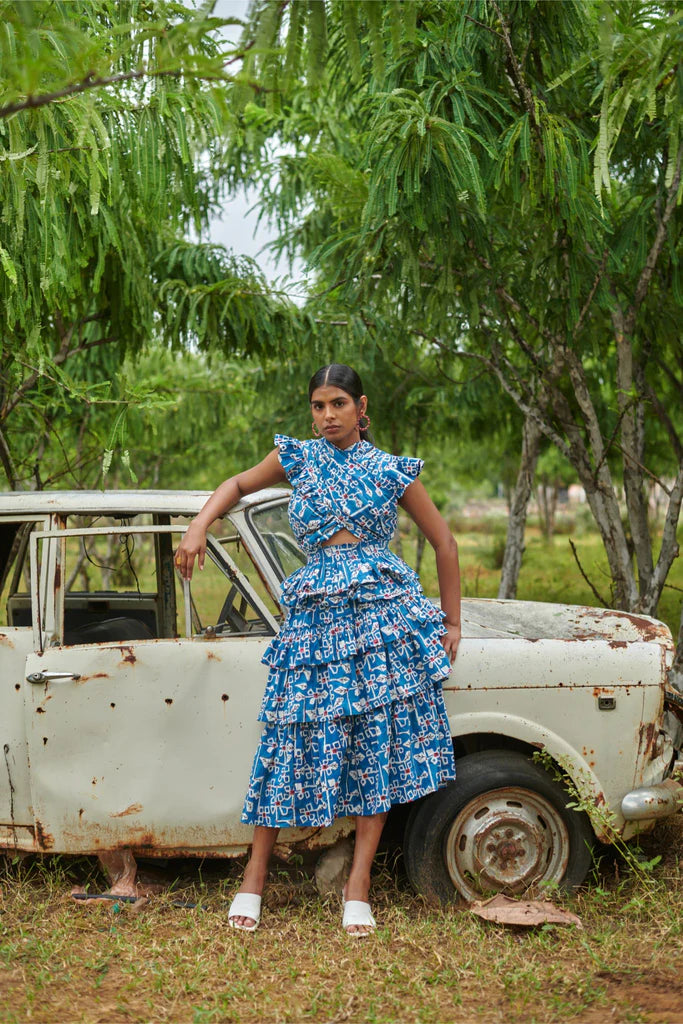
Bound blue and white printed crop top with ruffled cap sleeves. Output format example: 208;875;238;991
275;434;424;554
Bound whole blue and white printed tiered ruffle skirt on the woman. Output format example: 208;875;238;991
242;543;456;827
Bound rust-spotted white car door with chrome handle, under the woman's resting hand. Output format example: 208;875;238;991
25;526;315;854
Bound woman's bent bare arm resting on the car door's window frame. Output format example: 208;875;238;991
175;449;287;580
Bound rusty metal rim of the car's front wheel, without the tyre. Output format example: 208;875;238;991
445;786;569;899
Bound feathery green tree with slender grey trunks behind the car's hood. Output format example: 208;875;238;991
232;0;683;638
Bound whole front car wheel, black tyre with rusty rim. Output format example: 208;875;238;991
403;751;594;902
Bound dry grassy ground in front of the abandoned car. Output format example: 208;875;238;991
0;815;683;1024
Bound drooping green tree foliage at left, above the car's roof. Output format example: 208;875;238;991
0;0;298;487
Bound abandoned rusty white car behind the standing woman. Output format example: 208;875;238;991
0;489;682;900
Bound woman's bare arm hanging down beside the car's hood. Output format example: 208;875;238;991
398;480;461;664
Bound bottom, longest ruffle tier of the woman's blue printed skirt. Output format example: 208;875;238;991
242;686;456;827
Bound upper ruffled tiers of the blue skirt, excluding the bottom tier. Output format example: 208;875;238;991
259;544;451;724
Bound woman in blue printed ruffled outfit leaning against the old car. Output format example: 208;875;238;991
176;364;460;936
